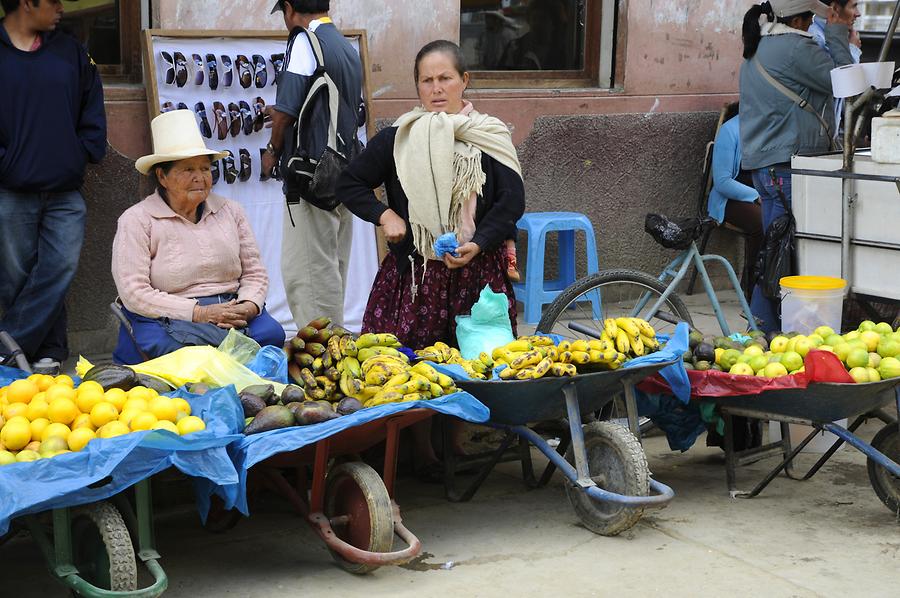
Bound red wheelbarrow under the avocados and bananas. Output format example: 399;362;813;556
206;408;434;575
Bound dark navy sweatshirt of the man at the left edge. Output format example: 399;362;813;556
0;21;106;193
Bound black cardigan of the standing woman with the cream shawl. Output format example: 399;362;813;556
336;127;525;268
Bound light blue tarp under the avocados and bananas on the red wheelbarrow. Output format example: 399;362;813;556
196;392;490;520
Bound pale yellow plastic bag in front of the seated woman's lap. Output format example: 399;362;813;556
76;346;285;394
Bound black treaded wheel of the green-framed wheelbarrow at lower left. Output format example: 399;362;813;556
72;502;137;592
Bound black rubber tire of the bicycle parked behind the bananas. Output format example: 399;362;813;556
537;270;693;338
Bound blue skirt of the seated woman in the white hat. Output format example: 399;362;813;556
113;295;284;365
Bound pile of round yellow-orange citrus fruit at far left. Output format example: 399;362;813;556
0;374;206;465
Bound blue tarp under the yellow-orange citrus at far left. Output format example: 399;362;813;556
0;378;244;536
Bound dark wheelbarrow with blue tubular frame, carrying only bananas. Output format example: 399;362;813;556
447;359;677;536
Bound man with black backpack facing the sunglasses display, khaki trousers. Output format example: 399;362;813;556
262;0;363;328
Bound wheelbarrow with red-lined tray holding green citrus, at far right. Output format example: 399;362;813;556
703;378;900;514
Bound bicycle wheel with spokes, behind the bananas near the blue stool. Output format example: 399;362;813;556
537;270;693;339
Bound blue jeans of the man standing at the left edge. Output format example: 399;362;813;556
0;187;87;361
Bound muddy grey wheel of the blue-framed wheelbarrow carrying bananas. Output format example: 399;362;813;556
566;421;650;536
